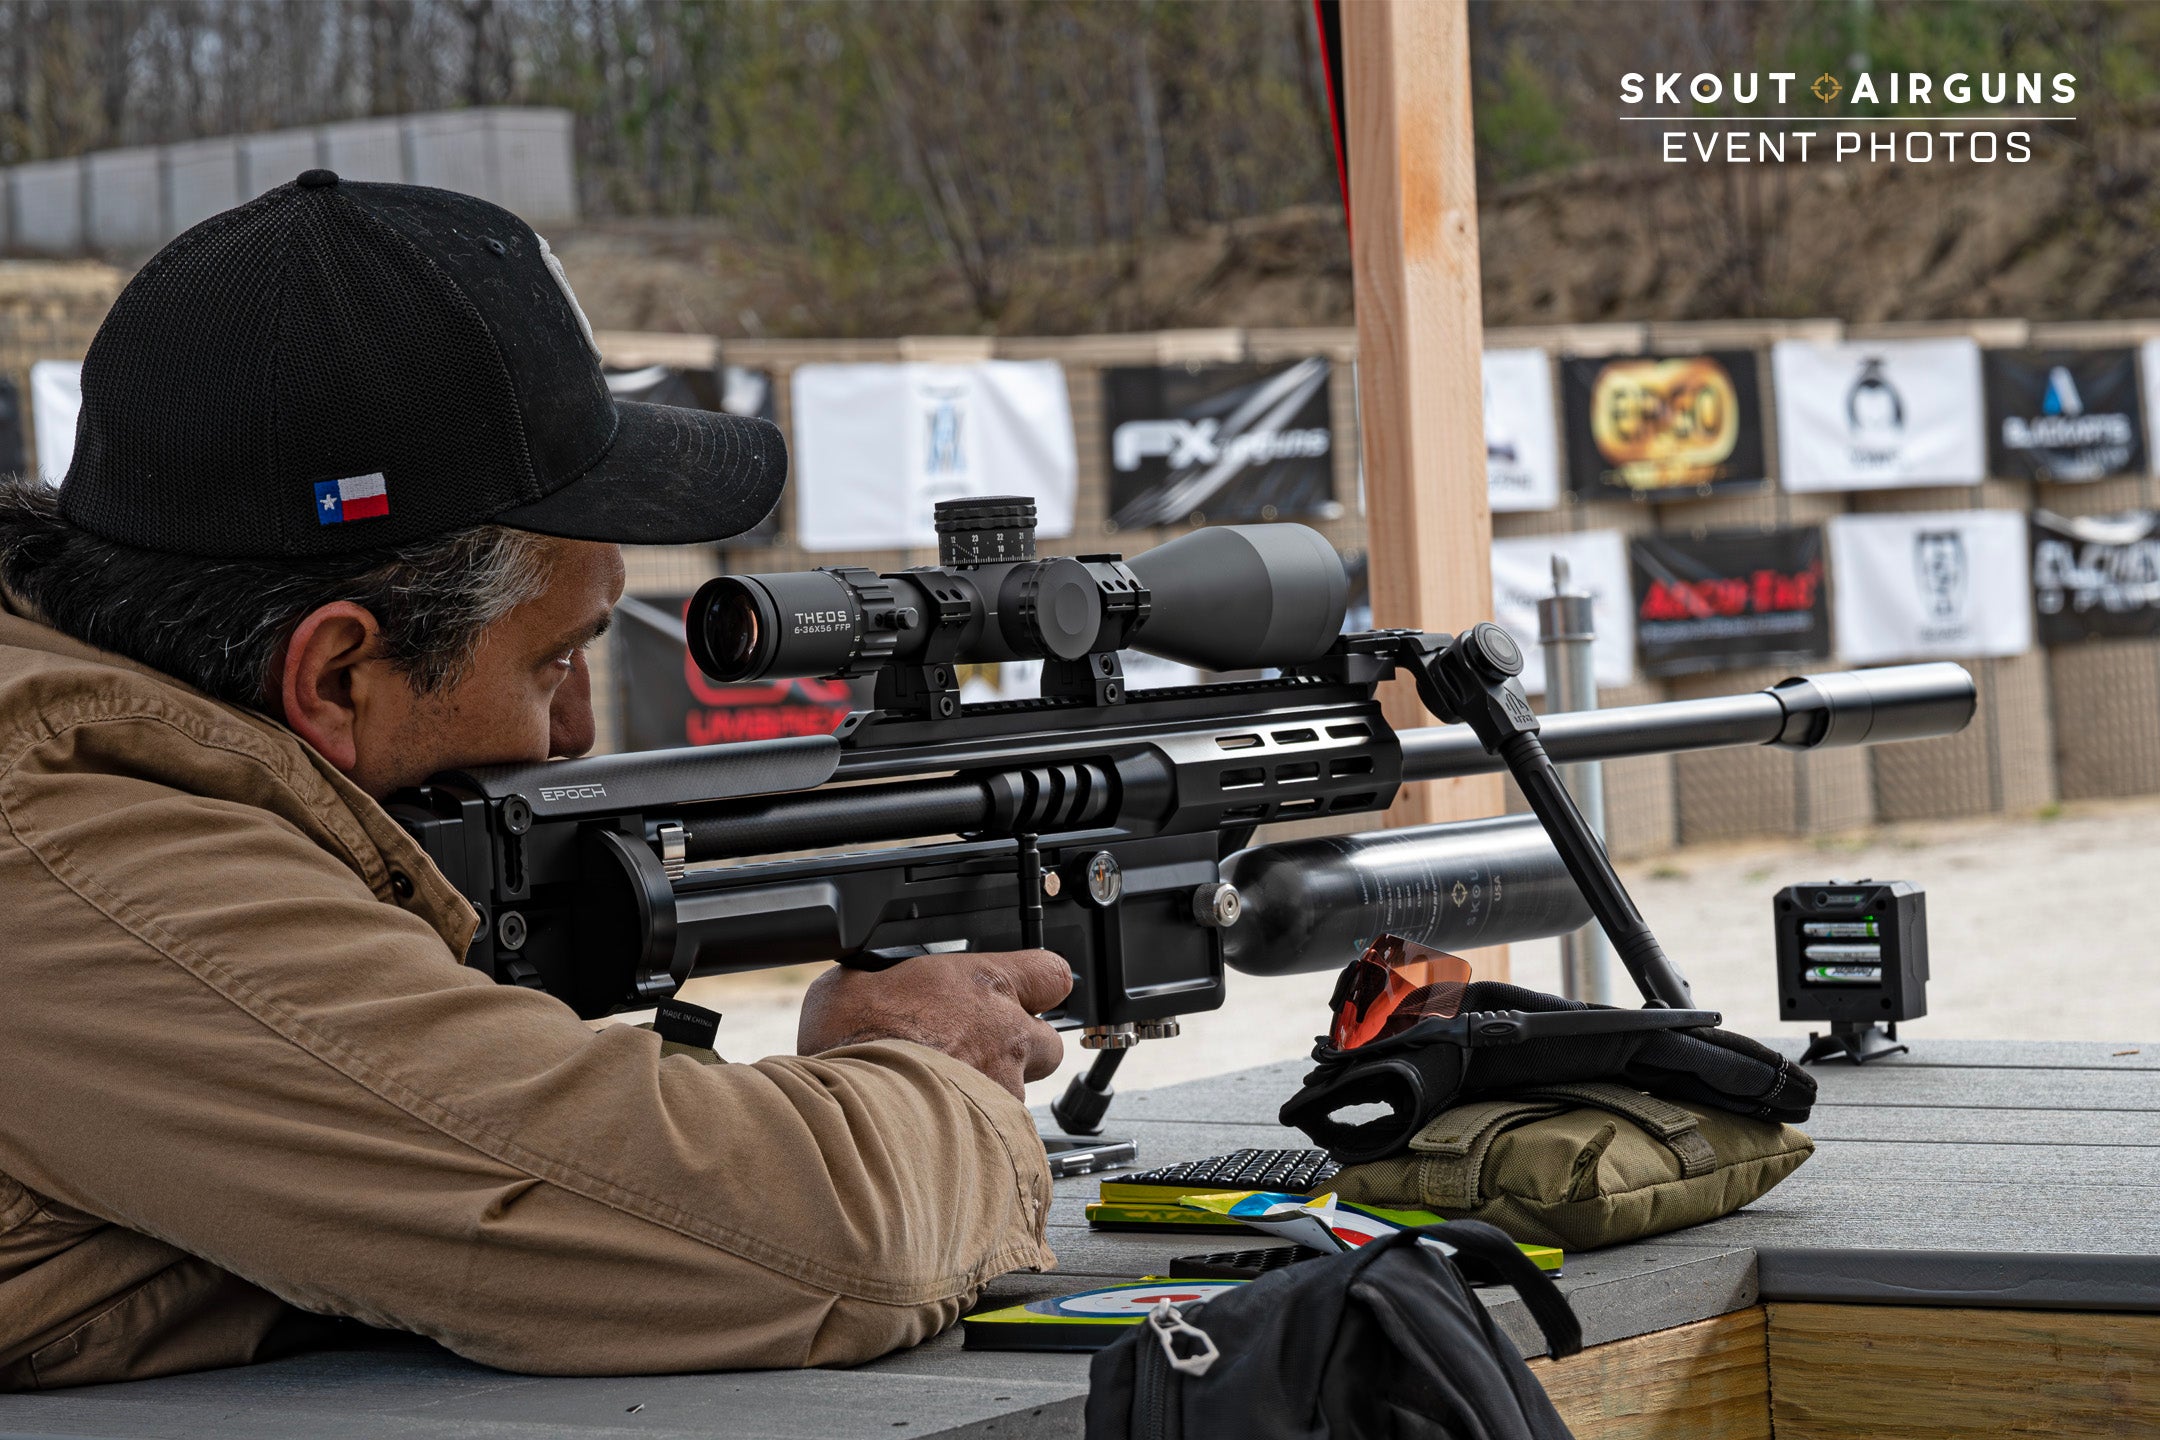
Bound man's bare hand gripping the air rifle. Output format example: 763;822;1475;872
795;950;1074;1097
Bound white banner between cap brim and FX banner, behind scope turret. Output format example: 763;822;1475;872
791;361;1080;551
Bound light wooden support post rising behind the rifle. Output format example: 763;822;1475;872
1341;0;1506;825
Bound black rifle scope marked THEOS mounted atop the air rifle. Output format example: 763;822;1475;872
685;497;1350;682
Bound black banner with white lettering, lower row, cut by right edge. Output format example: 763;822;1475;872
2030;510;2160;646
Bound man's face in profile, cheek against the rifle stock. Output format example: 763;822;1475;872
333;540;624;799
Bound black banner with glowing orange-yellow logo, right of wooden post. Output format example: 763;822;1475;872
1560;350;1767;501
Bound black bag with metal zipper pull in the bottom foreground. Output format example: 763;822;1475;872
1086;1220;1583;1440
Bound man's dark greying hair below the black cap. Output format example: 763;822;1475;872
0;475;549;710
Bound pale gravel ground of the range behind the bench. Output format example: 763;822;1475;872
652;799;2160;1101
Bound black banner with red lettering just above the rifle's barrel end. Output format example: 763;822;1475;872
1629;525;1830;676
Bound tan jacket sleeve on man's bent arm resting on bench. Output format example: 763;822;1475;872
0;782;1050;1373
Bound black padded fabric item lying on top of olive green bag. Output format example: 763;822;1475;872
1281;980;1814;1166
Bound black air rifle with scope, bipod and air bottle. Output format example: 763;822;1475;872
391;499;1974;1133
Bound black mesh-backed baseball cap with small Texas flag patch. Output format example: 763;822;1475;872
60;171;786;559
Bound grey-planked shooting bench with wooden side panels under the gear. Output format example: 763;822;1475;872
0;1038;2160;1440
